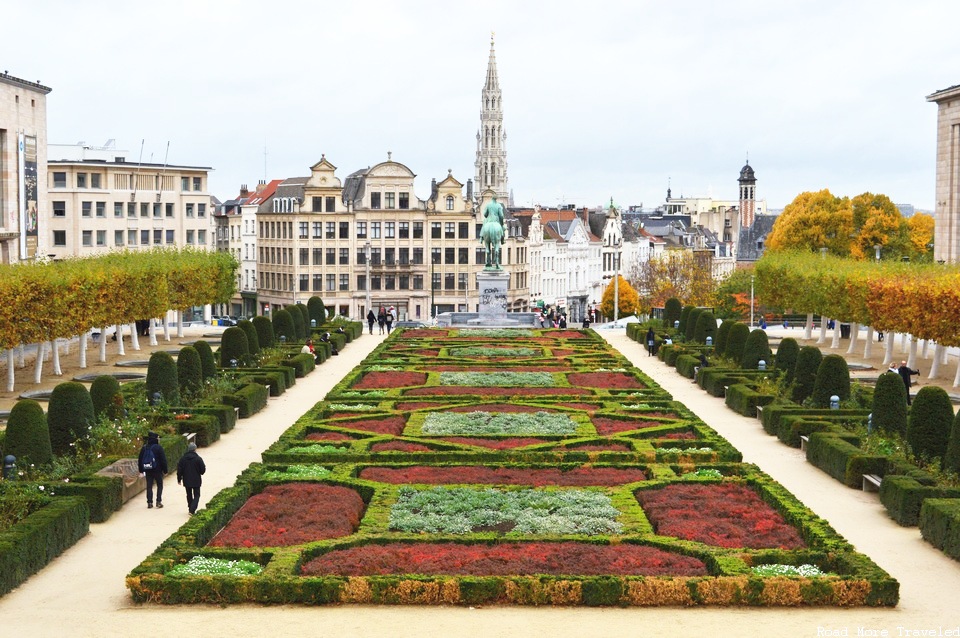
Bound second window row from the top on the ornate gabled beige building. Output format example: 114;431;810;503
260;220;481;239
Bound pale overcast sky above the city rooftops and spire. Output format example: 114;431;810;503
9;0;960;210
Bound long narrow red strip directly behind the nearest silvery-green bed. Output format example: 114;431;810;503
360;465;647;487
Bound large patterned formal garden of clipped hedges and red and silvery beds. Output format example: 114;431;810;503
127;328;899;606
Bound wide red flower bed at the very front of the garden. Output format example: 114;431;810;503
302;543;707;576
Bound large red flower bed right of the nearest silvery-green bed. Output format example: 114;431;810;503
635;483;806;549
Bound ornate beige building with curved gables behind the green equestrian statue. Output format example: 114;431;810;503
256;154;528;321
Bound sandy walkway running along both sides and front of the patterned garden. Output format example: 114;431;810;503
0;330;960;638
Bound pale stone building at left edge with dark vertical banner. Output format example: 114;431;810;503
0;71;51;264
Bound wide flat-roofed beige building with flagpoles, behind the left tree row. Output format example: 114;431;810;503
41;140;214;259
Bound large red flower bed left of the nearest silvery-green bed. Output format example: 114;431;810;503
210;483;365;547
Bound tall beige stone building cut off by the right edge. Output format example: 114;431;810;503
927;85;960;262
